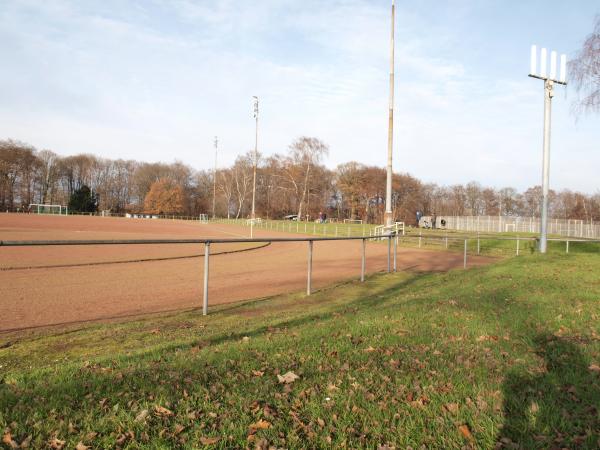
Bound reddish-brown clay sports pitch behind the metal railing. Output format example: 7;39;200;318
0;213;491;332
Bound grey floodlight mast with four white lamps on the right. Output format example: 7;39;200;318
529;45;567;253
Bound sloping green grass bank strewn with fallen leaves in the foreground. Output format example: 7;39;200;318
0;254;600;449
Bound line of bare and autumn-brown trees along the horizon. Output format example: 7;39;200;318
0;137;600;224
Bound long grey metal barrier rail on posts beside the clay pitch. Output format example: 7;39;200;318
0;234;600;315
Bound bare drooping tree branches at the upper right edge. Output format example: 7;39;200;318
569;15;600;115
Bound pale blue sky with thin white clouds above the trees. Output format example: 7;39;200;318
0;0;600;193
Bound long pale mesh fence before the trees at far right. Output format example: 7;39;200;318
436;216;600;239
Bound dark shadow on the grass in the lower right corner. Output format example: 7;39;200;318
496;334;600;449
